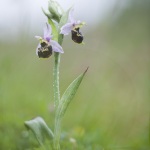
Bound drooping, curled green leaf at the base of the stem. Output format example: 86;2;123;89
24;117;54;145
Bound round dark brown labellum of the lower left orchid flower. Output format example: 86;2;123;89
38;42;52;58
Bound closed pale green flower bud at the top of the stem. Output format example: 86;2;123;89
48;0;63;22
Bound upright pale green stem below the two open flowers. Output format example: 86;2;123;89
53;53;61;150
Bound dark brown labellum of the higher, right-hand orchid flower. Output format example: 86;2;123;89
71;28;83;43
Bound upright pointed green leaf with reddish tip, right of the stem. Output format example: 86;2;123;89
56;68;88;118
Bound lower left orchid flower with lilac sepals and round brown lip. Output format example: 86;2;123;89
35;23;64;58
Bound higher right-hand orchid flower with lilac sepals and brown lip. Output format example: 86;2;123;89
60;9;85;43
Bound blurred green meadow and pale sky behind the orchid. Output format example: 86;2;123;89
0;0;150;150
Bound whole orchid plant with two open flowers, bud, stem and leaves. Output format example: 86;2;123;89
25;0;87;150
